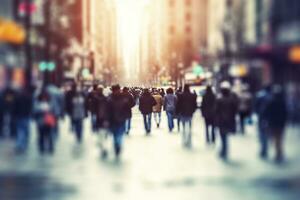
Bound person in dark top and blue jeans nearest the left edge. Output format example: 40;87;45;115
14;89;33;152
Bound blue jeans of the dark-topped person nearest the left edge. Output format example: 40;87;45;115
16;117;30;151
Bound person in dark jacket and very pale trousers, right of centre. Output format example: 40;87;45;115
177;85;197;147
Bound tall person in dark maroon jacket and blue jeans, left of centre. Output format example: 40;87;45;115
108;85;127;159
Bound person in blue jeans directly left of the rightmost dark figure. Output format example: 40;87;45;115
254;85;272;159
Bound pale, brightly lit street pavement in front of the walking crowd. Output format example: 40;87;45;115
0;110;300;200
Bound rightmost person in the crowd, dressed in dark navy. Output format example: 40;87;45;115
265;86;288;162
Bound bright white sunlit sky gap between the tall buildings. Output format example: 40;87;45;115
116;0;150;82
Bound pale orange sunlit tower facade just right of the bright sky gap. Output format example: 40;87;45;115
165;0;208;66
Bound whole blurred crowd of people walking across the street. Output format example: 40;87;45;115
0;81;288;162
